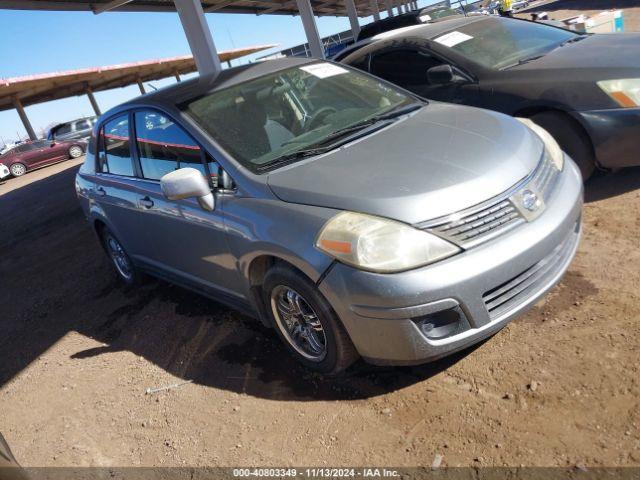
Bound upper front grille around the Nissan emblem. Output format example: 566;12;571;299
418;150;559;248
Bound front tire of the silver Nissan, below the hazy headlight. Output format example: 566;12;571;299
263;265;359;375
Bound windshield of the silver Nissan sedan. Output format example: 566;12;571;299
186;63;417;171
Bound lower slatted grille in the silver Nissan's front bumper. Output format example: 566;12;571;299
482;224;579;320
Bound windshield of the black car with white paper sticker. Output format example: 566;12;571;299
432;18;581;69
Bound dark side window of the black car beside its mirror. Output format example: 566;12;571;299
371;49;442;88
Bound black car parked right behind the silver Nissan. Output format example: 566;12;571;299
341;16;640;178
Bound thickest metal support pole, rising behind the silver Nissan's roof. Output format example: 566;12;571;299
173;0;222;76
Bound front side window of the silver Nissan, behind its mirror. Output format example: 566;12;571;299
135;111;206;180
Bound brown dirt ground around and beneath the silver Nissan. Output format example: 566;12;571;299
0;157;640;466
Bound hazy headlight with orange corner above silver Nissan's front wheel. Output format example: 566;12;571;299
316;212;460;273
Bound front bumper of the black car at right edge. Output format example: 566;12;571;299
577;108;640;168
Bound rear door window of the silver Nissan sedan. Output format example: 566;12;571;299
98;115;133;177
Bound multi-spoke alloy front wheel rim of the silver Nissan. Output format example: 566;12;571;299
271;285;327;362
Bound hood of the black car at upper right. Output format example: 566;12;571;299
512;33;640;73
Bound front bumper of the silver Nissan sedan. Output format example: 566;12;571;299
319;158;583;365
